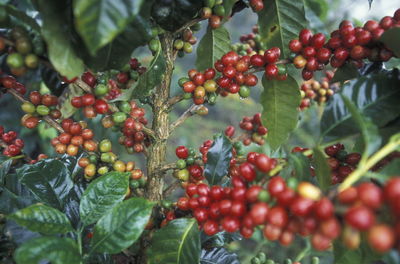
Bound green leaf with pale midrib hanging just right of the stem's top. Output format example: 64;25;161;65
196;26;231;71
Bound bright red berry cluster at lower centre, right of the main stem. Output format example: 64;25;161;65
177;152;276;238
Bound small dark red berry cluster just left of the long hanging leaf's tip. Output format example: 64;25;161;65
234;113;268;146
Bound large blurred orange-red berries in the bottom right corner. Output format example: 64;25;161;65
338;177;400;253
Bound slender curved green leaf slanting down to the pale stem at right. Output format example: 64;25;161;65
342;95;382;157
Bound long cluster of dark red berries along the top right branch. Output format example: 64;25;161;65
289;9;400;80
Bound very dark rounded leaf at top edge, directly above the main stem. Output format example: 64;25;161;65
151;0;203;31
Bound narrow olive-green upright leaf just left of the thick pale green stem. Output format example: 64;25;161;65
313;147;332;191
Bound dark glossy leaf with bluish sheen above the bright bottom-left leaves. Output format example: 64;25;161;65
17;159;74;210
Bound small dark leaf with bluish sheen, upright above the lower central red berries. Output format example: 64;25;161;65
204;136;232;185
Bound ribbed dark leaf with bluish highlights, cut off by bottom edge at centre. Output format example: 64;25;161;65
200;247;240;264
